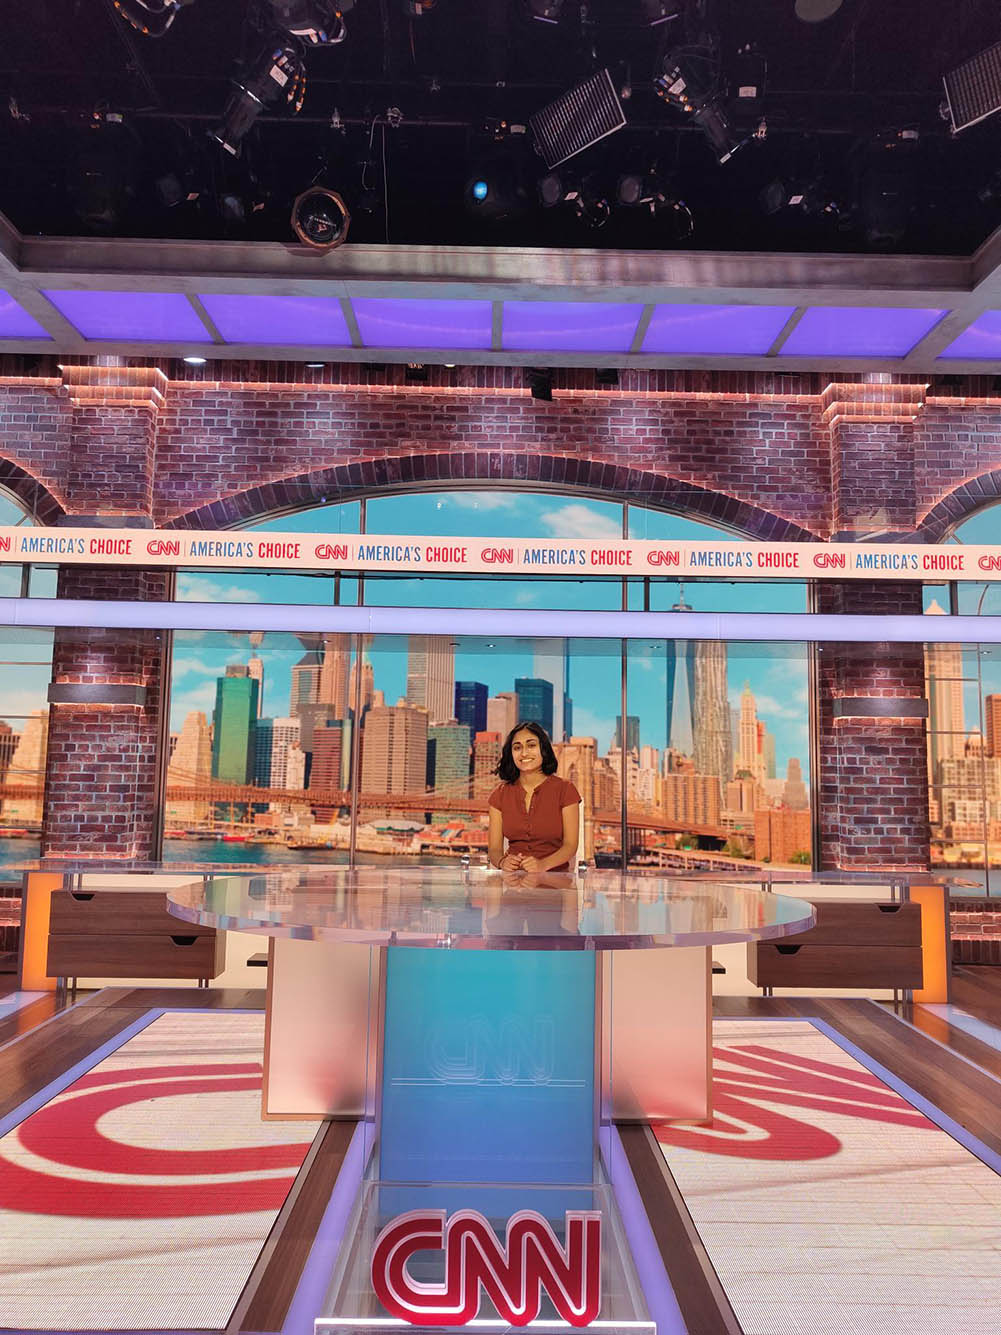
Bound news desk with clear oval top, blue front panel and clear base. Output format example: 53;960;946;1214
168;866;814;1335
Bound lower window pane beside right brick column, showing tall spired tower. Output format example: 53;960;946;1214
627;641;811;872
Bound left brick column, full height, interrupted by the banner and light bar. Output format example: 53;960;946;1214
41;358;172;858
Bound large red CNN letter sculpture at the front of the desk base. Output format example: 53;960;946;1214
372;1210;602;1326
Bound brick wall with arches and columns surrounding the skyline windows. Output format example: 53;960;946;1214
0;358;1001;868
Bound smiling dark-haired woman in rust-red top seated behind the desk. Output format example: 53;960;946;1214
488;722;581;872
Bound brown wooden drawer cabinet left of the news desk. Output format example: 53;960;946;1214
45;890;226;979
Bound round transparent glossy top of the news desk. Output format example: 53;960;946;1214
167;866;814;951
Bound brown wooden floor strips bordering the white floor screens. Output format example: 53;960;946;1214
0;967;1001;1335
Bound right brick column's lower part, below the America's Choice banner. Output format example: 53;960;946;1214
817;582;929;872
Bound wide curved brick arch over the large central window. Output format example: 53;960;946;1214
167;451;815;542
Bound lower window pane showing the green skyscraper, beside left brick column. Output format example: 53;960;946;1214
163;631;354;862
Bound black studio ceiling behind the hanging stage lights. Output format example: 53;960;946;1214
0;0;1001;254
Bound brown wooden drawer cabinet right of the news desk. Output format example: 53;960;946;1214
747;900;924;988
